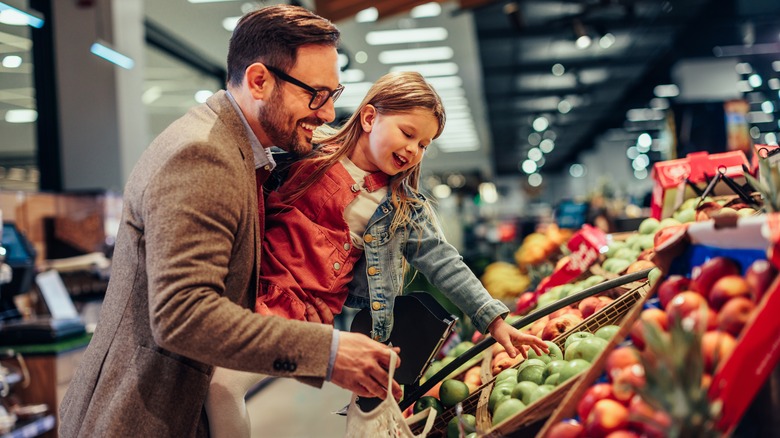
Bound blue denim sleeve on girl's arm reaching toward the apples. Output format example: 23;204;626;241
404;209;509;333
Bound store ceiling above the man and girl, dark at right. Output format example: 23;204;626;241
0;0;780;184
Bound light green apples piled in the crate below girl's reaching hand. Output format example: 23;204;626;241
488;325;618;426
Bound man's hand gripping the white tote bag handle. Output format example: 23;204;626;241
330;331;403;400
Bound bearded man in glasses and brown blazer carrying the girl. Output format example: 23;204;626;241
60;5;400;437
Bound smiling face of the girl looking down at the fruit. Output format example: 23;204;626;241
349;105;439;176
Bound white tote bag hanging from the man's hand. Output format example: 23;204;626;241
346;350;436;438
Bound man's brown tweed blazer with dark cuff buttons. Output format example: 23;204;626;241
60;91;333;438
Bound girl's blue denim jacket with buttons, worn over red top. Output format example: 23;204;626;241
345;190;509;341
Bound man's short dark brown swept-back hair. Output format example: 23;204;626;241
222;5;341;86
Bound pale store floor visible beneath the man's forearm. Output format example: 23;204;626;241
247;379;352;438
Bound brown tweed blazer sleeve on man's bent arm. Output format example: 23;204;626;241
141;144;333;385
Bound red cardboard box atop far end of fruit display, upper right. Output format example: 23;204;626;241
650;151;750;219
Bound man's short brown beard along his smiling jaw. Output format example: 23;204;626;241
257;89;311;156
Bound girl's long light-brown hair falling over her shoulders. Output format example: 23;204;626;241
288;72;446;232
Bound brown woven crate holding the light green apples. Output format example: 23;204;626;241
476;281;651;437
